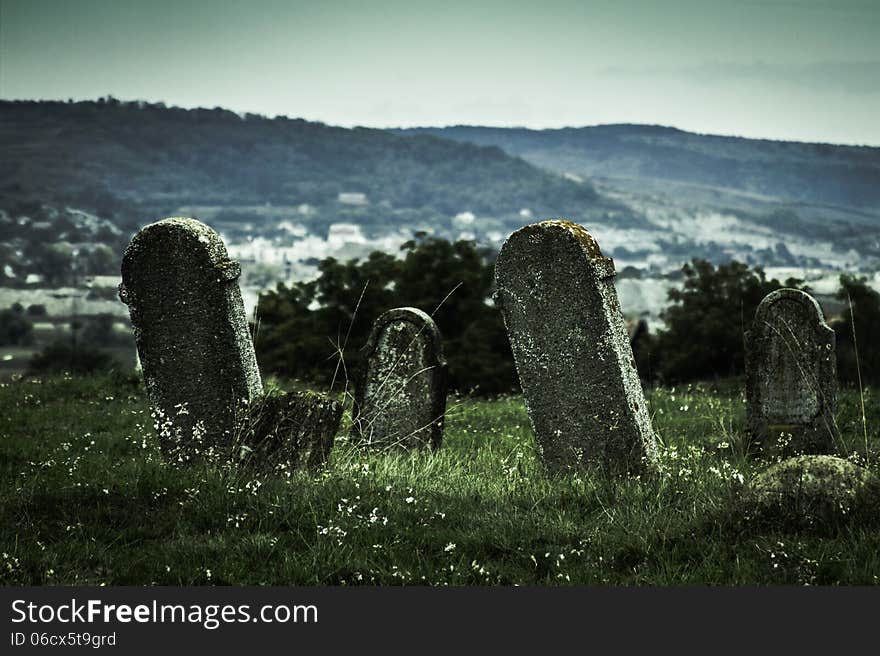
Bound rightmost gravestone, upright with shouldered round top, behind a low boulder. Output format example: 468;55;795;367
746;289;837;453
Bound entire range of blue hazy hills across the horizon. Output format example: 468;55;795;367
0;99;880;274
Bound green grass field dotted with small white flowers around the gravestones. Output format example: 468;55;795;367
0;376;880;585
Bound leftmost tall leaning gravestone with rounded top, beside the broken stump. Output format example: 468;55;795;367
119;218;262;461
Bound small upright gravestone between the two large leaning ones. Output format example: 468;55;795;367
353;307;446;449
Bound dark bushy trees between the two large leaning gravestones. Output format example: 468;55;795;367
254;240;517;394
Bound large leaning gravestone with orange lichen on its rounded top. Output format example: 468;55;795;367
495;220;655;473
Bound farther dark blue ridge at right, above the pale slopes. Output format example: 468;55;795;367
400;125;880;215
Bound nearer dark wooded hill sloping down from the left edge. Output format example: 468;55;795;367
0;99;638;234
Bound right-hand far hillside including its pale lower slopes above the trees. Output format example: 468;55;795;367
395;125;880;270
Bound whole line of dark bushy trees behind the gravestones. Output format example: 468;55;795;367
255;241;880;394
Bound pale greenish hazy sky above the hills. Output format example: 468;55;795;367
0;0;880;145
